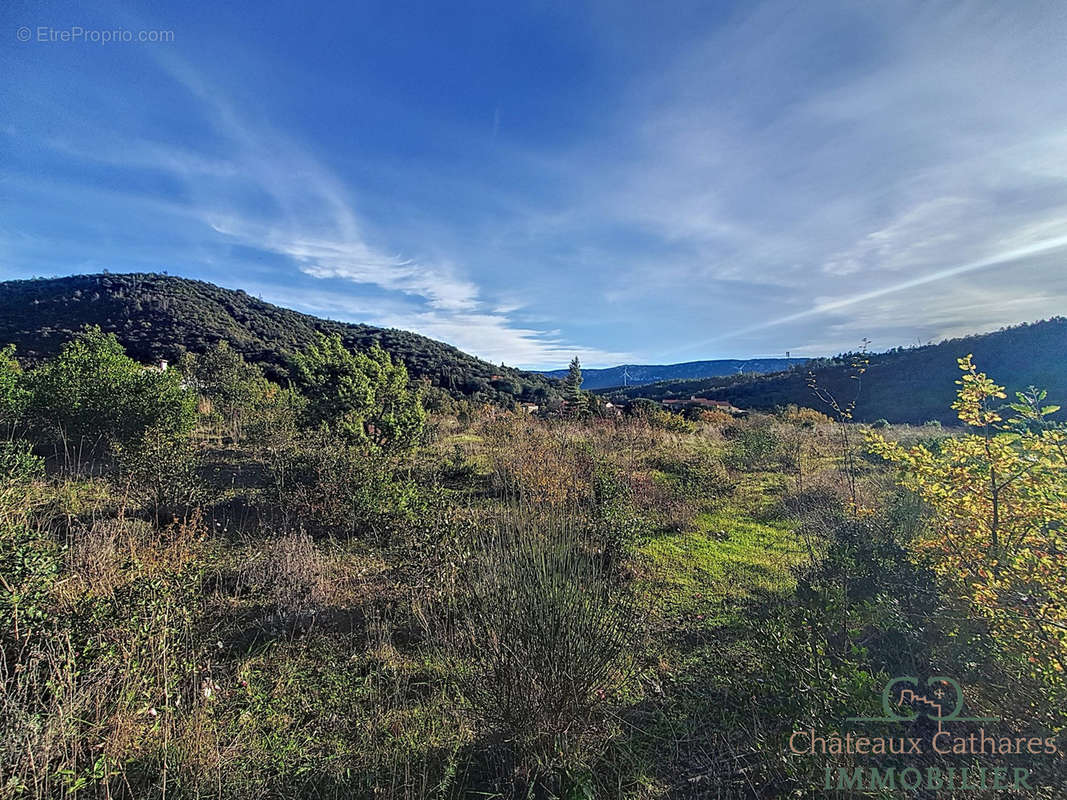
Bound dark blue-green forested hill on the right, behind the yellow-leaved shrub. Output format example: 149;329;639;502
609;317;1067;423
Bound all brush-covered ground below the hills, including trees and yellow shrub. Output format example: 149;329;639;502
0;330;1067;800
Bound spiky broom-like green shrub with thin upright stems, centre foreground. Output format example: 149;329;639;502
445;516;640;780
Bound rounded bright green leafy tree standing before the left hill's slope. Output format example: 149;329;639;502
294;335;426;453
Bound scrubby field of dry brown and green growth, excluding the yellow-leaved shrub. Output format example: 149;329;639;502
0;332;1065;799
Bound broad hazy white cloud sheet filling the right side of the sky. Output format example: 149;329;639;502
542;2;1067;355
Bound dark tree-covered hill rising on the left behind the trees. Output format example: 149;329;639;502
0;273;553;401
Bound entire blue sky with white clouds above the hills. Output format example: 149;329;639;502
0;0;1067;368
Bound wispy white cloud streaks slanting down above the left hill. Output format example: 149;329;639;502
97;55;625;367
